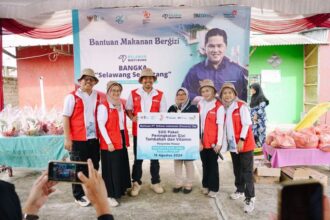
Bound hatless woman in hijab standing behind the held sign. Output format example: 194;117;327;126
168;87;198;194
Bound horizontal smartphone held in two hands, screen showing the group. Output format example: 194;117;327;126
48;161;88;184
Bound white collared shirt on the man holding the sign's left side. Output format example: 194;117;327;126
126;88;167;112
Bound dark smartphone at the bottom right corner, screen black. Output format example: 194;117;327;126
278;180;323;220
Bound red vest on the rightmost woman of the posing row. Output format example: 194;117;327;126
232;101;256;152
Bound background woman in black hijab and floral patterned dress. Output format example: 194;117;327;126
250;83;269;147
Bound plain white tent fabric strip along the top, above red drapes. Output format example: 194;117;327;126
0;0;330;19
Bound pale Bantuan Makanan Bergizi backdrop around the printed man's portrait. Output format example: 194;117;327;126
73;6;250;102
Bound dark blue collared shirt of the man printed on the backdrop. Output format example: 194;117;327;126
182;57;248;101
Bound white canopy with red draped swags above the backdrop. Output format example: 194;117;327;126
0;0;330;109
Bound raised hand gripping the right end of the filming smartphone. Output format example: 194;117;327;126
78;159;110;217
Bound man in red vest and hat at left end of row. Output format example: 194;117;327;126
63;69;100;207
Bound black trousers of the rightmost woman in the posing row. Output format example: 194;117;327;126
230;151;255;198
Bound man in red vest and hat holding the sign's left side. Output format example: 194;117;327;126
126;68;167;196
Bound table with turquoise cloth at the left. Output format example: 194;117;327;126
0;135;69;169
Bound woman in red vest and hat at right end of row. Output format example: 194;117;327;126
217;83;256;213
